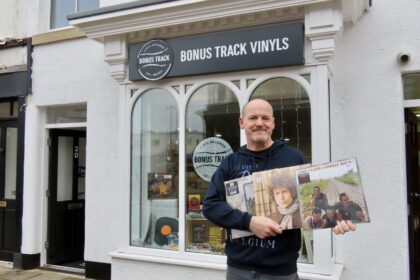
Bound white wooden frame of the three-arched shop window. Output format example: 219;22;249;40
115;64;334;279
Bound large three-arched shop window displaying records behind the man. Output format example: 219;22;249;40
128;71;333;274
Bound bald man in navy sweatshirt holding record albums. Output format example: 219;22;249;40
203;99;354;280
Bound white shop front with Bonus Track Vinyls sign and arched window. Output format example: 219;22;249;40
69;1;368;279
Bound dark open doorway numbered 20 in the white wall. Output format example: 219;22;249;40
47;129;86;268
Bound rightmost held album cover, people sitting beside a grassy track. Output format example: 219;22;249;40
296;158;370;229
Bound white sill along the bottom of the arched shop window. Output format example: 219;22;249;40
109;252;344;280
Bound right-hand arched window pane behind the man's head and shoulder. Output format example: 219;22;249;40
251;78;313;263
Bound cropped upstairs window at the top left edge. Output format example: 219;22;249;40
50;0;99;29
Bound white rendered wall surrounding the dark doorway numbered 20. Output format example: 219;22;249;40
28;39;121;263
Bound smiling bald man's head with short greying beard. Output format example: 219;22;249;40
239;100;275;150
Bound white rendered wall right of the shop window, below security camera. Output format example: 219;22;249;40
331;0;420;280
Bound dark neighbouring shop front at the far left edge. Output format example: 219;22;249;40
0;40;28;268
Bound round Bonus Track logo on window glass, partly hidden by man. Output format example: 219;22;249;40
192;137;233;182
